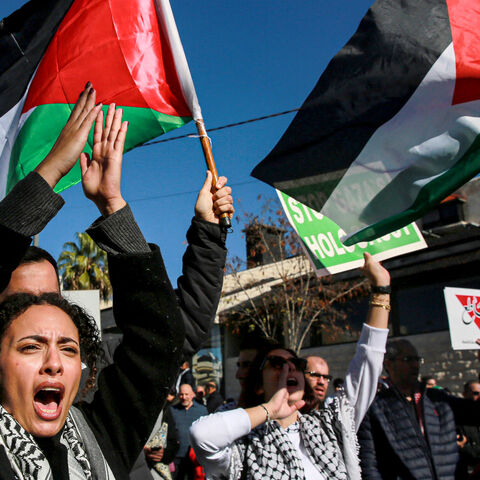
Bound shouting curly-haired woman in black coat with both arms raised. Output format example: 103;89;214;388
0;87;189;480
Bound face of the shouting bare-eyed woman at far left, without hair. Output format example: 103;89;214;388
0;305;82;437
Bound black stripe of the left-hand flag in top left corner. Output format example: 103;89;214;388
0;0;73;117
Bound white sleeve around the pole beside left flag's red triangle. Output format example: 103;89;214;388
155;0;202;120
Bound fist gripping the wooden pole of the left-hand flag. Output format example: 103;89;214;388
195;170;235;223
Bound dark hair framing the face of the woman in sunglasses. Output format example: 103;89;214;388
242;342;315;413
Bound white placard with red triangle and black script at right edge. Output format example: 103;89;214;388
443;287;480;350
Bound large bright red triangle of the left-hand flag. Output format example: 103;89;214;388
23;0;191;116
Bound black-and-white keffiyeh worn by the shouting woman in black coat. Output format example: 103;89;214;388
0;405;113;480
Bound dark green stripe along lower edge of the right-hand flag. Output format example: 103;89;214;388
343;135;480;246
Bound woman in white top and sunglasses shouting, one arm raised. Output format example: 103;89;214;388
190;254;390;480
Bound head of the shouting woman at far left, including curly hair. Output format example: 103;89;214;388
0;293;101;436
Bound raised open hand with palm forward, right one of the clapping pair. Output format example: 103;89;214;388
80;103;128;217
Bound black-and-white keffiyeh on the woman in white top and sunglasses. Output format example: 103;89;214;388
229;394;361;480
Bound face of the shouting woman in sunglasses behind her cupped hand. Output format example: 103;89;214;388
259;348;305;405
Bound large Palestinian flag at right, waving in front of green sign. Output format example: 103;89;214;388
252;0;480;245
